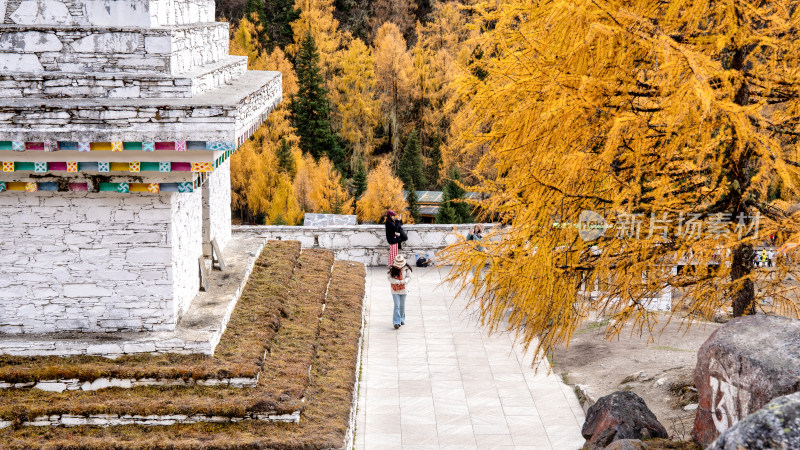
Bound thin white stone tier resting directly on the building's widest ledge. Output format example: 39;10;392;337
0;55;247;98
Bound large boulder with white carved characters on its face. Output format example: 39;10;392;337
692;314;800;447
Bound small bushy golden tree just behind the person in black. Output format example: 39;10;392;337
356;159;412;223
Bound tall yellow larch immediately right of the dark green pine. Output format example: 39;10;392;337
331;39;380;171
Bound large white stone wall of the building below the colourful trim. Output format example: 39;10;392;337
0;192;202;333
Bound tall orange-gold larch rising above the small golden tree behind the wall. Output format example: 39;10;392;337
373;22;414;163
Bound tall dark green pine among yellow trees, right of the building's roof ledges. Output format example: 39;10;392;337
291;31;344;167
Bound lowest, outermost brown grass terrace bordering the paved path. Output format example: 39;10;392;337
0;259;366;449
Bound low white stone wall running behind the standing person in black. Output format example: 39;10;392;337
228;224;494;266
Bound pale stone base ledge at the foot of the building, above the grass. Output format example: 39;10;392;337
0;237;265;358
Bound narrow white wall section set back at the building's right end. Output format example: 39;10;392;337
203;159;231;256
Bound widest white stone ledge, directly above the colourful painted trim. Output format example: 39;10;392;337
0;71;282;143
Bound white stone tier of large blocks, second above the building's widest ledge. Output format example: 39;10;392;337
0;22;228;75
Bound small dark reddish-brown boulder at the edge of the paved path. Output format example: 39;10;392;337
581;391;667;449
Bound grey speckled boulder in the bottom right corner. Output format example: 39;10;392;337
709;392;800;450
